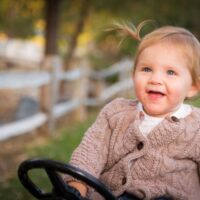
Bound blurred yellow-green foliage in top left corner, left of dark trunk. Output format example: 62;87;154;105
0;0;44;38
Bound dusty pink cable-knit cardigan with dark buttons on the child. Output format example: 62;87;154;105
66;98;200;200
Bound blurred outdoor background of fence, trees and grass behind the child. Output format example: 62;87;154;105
0;0;200;200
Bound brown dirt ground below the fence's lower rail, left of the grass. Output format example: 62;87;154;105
0;130;50;183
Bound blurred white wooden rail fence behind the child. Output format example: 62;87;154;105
0;57;133;140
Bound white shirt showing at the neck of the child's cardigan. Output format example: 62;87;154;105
137;102;192;136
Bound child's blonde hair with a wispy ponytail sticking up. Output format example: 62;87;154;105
113;20;200;86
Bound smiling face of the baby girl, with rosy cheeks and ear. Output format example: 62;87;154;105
133;42;197;117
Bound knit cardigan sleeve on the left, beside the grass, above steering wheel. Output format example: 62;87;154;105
67;100;116;181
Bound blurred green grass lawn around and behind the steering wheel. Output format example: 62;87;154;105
0;98;200;200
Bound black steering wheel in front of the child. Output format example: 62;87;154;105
18;159;117;200
